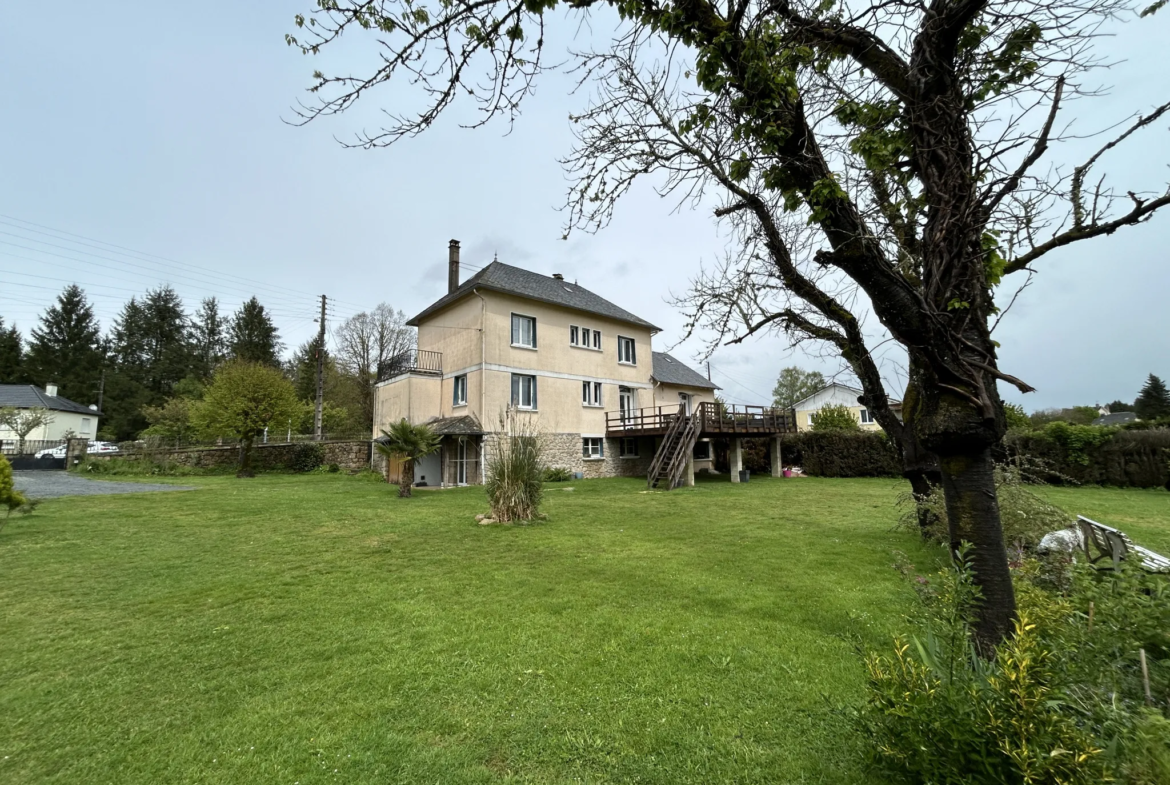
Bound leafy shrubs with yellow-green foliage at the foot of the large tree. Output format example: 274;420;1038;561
860;552;1170;785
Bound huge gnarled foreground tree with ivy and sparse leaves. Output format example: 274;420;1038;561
289;0;1170;653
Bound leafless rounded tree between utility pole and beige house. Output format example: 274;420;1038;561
333;303;418;428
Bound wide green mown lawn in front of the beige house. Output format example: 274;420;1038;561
0;475;1170;785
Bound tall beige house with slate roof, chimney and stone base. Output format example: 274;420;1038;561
374;240;776;487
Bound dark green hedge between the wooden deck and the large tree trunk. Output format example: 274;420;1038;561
744;431;902;477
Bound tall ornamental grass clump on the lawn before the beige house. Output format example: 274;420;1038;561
486;415;544;523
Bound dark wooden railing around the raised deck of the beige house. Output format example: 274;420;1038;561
605;402;796;439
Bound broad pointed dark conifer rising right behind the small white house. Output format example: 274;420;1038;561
25;284;104;404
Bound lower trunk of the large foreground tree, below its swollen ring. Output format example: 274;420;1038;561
940;449;1016;656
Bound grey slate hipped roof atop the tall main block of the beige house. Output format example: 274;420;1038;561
407;262;659;331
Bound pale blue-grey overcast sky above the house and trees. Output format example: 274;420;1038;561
0;0;1170;409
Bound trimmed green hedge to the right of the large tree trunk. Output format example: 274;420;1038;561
1004;424;1170;490
